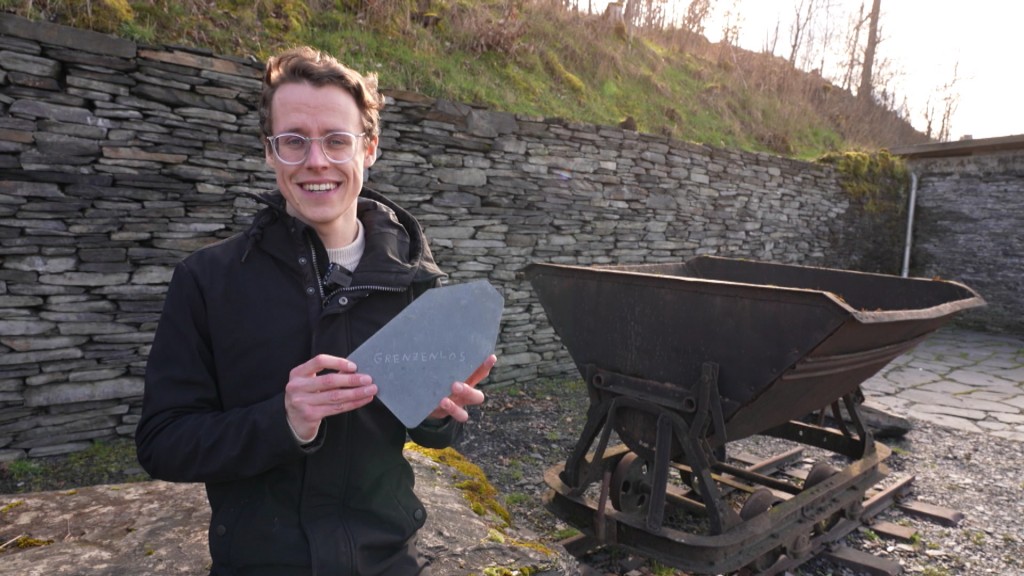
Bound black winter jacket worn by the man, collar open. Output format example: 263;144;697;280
136;190;460;576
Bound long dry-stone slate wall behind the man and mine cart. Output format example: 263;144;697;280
0;14;860;460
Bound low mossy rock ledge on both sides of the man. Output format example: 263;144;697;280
0;451;579;576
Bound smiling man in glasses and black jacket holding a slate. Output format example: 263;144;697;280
136;48;496;576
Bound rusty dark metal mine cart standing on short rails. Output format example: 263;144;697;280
526;256;984;575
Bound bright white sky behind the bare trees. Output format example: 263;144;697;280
704;0;1024;140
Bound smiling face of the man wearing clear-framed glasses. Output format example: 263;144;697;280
266;83;377;248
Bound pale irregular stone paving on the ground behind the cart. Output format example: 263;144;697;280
862;328;1024;442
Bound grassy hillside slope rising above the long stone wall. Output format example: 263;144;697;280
0;0;927;158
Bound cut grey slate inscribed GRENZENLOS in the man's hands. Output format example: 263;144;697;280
348;280;505;428
